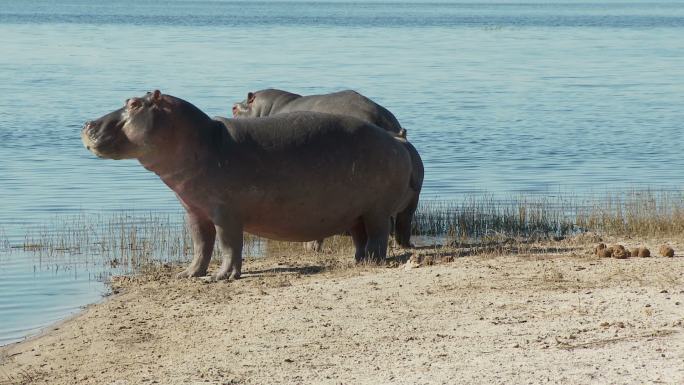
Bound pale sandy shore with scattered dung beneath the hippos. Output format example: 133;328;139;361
0;240;684;385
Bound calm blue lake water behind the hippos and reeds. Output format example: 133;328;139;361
0;0;684;344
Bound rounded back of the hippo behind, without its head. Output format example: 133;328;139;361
279;90;401;133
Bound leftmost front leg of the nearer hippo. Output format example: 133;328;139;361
177;211;216;278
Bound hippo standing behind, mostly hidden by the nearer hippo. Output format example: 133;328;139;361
233;89;424;250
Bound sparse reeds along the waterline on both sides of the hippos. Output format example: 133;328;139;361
9;190;684;271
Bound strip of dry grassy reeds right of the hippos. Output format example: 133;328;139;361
420;190;684;241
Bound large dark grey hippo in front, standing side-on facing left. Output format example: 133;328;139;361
81;91;411;279
